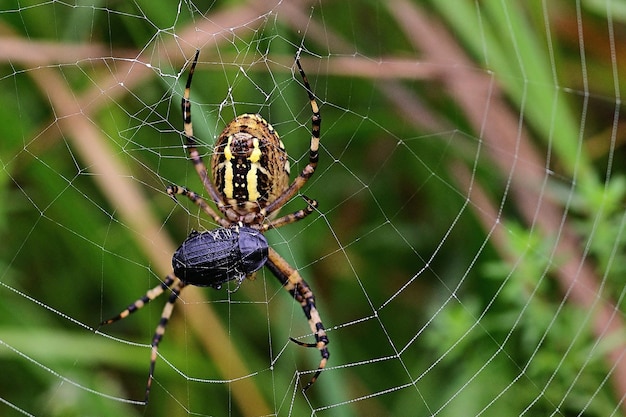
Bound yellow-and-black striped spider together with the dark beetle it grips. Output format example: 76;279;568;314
101;50;330;404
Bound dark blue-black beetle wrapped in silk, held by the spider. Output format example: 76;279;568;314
172;226;268;289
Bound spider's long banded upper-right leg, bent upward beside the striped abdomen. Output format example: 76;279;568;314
259;57;322;217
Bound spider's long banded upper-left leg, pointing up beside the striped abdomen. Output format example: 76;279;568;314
181;50;228;213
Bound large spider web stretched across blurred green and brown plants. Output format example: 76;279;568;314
0;0;626;416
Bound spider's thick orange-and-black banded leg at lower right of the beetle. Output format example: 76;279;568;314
265;247;330;392
